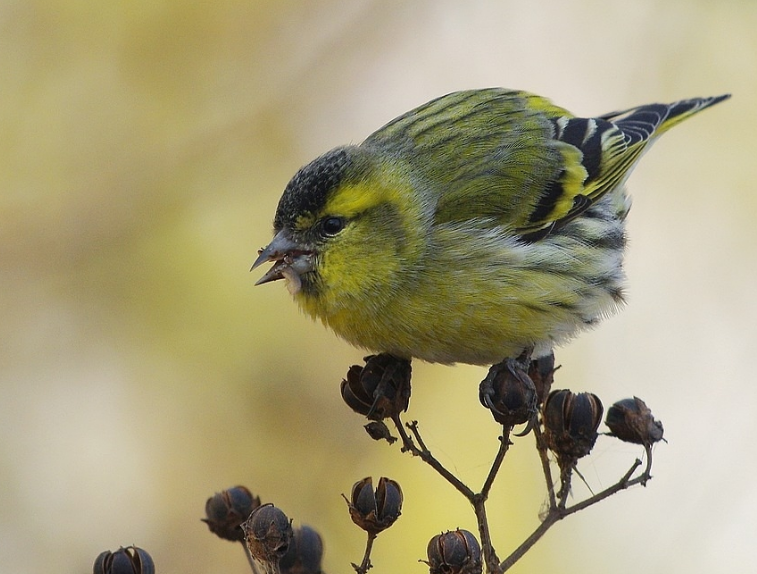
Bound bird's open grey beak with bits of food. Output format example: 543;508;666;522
250;229;314;295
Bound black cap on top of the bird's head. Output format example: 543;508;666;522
273;147;355;230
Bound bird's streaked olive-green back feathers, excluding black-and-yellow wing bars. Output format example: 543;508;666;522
362;89;568;234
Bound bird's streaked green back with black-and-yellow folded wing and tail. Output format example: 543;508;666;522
361;89;728;241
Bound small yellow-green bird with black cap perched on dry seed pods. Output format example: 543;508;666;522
253;88;729;365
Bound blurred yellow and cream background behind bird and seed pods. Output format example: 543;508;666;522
0;0;757;574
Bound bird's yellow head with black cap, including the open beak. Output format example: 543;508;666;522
252;146;423;318
